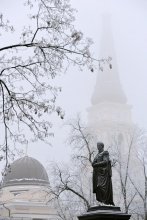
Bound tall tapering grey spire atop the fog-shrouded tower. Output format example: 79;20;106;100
91;15;127;105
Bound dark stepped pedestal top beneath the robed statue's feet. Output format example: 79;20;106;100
78;206;131;220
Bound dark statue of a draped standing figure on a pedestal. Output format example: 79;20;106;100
92;142;114;205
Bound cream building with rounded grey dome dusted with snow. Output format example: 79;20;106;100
0;156;57;220
